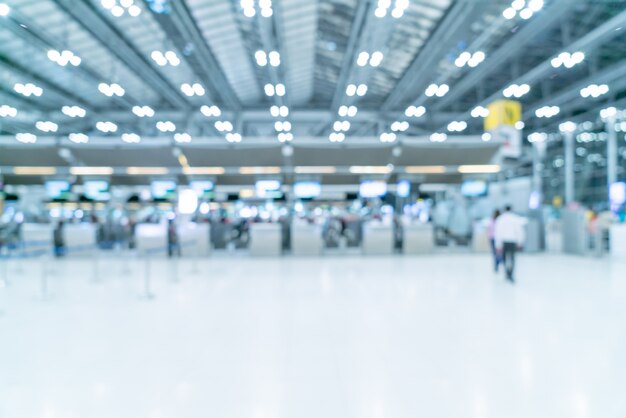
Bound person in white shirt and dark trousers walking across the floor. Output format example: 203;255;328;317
494;206;526;283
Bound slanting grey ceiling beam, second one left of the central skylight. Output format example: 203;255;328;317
54;0;188;108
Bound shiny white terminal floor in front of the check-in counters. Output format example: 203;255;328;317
0;251;626;418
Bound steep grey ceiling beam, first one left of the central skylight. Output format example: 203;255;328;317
146;0;241;110
